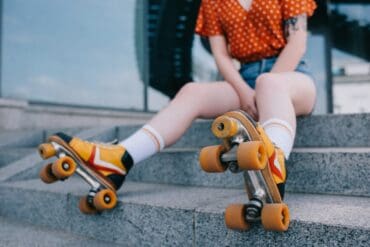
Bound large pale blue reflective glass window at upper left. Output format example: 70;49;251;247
2;0;143;110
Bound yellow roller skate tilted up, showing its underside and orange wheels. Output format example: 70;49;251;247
199;111;290;231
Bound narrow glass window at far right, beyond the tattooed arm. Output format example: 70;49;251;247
331;4;370;113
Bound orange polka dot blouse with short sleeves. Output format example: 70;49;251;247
195;0;316;62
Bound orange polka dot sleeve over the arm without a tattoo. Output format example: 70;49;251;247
195;0;223;37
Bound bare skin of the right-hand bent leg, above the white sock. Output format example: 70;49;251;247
256;72;316;131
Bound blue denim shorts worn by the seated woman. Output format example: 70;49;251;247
239;57;315;89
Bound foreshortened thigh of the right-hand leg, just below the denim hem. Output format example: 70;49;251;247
279;72;316;116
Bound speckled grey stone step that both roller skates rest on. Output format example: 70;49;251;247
0;179;370;246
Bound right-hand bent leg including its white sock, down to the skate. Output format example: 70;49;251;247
256;72;316;159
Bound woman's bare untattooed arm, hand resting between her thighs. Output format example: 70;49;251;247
210;35;258;119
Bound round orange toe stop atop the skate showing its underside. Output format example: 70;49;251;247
212;116;238;138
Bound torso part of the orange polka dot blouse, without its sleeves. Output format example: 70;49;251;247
217;0;286;62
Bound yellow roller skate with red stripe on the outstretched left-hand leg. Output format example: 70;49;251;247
38;133;133;214
